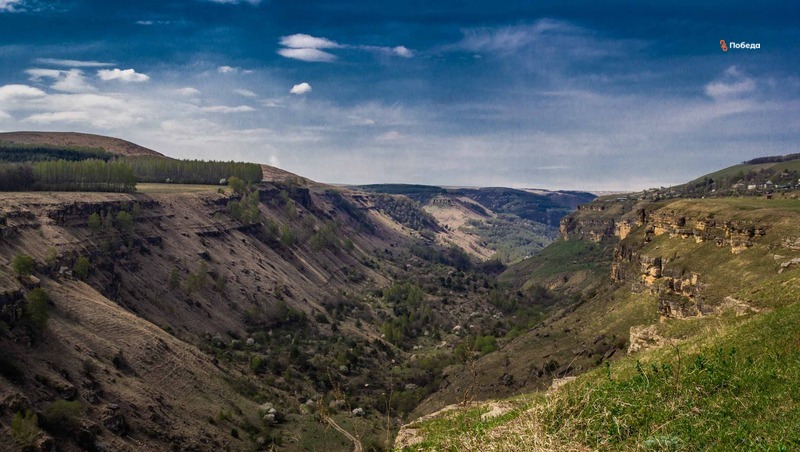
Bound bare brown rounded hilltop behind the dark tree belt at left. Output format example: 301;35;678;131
0;132;164;157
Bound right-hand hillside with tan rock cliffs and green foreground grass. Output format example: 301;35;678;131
398;183;800;450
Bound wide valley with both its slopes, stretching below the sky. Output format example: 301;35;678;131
0;133;800;450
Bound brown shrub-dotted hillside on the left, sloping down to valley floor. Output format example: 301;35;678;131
0;133;564;450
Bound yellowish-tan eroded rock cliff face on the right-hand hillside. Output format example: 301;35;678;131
561;201;776;318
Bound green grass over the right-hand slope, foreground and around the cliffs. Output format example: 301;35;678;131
400;198;800;451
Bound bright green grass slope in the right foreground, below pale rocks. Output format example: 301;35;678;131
406;278;800;451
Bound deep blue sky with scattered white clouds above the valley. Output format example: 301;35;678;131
0;0;800;190
